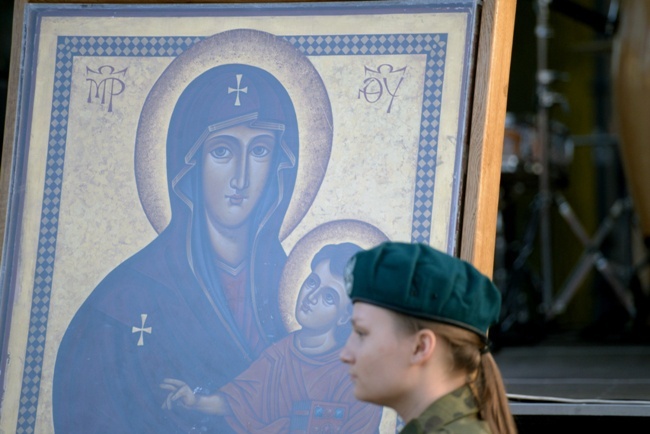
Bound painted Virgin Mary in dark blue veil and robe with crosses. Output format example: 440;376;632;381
53;59;308;434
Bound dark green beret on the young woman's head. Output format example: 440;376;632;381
345;242;501;337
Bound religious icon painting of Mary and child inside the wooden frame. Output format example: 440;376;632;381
0;0;479;434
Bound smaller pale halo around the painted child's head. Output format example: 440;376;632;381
278;220;388;332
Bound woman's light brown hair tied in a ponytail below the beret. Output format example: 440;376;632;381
393;312;517;434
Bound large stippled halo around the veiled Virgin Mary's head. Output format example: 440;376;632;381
135;29;333;240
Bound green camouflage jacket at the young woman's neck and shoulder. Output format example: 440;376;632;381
400;386;490;434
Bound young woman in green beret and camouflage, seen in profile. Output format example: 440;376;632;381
341;243;516;434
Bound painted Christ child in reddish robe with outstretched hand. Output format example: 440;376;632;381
160;243;381;434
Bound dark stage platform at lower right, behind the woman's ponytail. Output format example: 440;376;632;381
495;343;650;428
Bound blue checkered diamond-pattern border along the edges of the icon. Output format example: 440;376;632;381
16;34;447;434
